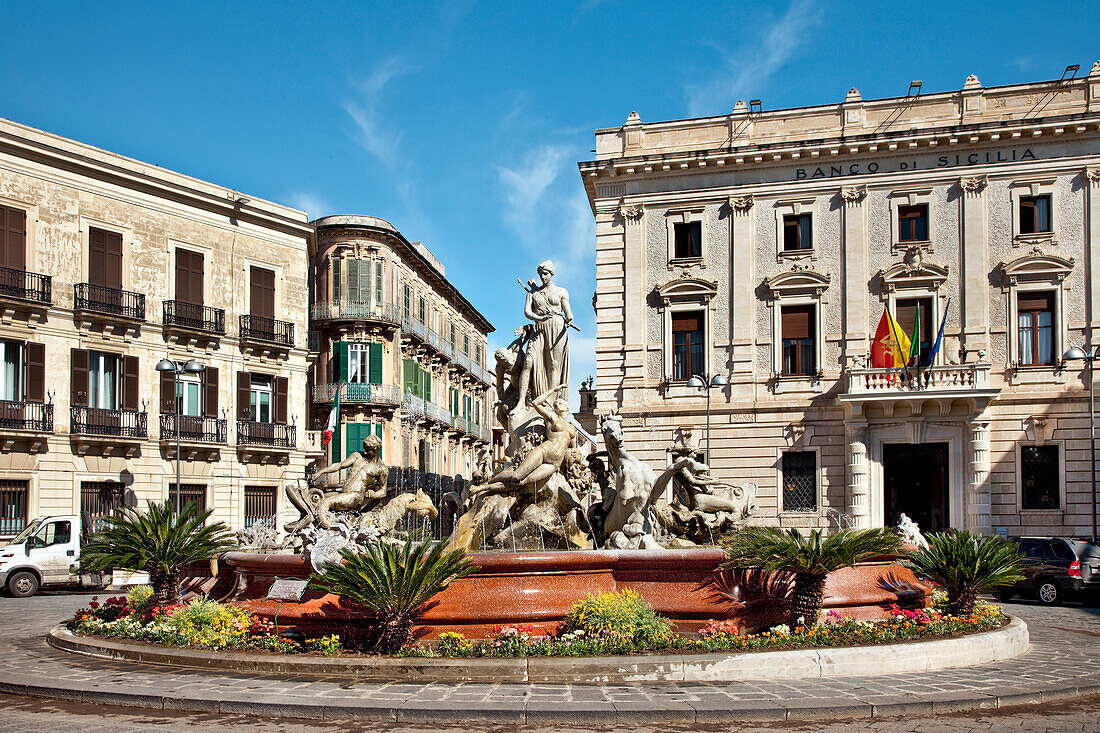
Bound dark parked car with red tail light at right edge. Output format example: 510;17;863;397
998;537;1100;605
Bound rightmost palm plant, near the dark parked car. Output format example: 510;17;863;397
902;530;1023;616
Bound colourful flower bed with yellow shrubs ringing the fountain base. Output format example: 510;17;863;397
70;589;1007;658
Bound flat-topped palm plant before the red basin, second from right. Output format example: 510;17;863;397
722;527;899;626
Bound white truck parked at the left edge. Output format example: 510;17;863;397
0;514;111;598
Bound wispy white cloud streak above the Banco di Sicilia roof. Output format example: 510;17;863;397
686;0;822;117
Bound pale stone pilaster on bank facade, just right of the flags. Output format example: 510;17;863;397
959;176;989;362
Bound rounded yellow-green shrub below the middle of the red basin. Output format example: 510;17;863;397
563;588;672;646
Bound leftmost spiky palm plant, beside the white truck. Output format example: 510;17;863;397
80;502;237;609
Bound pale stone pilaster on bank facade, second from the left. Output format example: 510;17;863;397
727;194;756;372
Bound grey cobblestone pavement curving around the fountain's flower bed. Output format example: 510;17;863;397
0;593;1100;730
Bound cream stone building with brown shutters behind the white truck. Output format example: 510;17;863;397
0;115;322;536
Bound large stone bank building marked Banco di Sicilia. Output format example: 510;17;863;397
580;63;1100;536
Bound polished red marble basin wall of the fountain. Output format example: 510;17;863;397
216;548;930;638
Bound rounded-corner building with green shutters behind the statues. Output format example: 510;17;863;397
310;216;493;490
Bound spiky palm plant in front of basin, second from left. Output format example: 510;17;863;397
311;539;479;653
